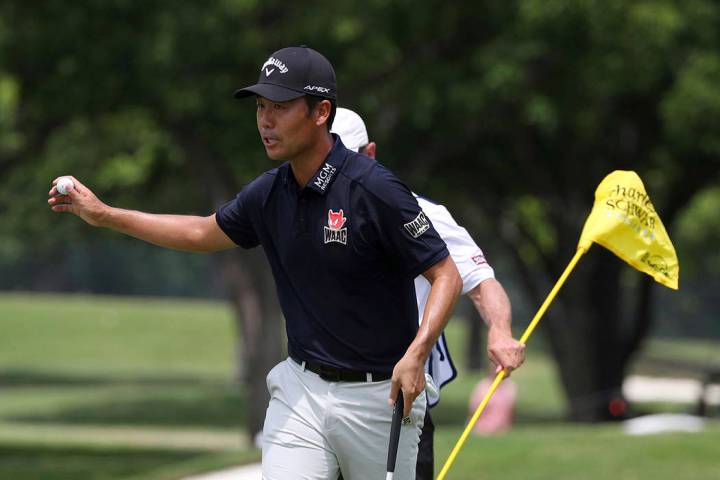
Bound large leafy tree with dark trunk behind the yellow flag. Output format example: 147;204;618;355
358;1;720;420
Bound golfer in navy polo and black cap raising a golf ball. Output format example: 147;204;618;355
48;46;462;480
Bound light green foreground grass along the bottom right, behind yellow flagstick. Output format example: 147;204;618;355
435;424;720;480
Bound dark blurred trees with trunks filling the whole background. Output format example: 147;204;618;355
0;0;720;432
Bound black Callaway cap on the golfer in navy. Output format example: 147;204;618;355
235;45;337;102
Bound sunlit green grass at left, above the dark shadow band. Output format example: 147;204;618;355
0;295;235;376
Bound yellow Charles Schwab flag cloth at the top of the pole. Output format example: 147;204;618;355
578;170;680;290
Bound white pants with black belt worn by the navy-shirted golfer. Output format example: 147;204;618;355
262;358;426;480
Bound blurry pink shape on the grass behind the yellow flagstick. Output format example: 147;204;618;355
469;378;517;435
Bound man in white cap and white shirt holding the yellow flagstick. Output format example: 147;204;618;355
332;107;525;480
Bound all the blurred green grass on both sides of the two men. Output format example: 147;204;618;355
0;294;720;480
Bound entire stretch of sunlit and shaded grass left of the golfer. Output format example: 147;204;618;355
0;294;259;480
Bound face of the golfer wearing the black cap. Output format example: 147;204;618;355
257;97;317;160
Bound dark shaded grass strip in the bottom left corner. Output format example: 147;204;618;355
0;445;207;480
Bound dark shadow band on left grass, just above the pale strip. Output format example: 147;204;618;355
7;386;250;430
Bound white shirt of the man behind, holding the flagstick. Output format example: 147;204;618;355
415;194;495;407
